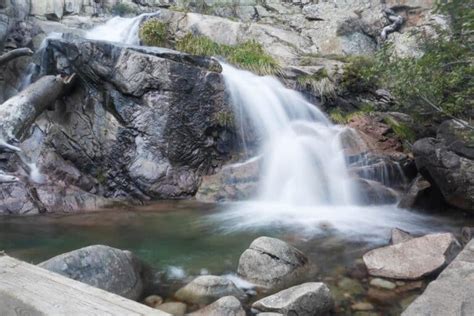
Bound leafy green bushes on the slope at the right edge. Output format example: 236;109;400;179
341;0;474;120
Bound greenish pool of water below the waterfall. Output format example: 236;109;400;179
0;201;467;314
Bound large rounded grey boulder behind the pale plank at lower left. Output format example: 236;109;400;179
39;245;144;300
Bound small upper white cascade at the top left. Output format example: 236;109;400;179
85;12;159;45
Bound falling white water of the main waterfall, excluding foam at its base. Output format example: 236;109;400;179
222;64;357;206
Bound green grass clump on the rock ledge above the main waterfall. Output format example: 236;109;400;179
176;33;280;75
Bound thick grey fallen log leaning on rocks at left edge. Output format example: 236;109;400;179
0;75;74;143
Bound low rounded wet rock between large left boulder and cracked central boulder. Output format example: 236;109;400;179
175;275;245;304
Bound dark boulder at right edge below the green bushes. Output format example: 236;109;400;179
413;120;474;211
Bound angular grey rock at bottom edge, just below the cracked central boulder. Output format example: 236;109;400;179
252;283;334;316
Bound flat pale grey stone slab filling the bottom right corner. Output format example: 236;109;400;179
402;241;474;316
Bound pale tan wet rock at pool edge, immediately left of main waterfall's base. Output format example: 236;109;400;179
196;159;261;202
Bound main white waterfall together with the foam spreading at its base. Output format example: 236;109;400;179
217;64;441;240
